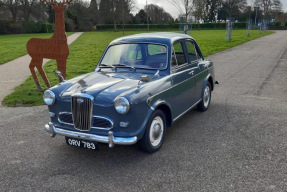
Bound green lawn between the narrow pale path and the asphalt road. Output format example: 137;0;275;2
2;30;272;107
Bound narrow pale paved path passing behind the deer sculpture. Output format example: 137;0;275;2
0;32;82;103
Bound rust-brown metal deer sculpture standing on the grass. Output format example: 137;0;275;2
27;0;72;91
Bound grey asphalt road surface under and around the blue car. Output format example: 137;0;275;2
0;31;287;192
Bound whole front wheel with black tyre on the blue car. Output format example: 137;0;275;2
140;110;166;153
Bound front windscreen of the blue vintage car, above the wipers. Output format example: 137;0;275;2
100;43;167;70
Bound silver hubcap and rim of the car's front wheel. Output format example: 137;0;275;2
149;116;163;147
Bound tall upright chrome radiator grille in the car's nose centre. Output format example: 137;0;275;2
71;94;94;131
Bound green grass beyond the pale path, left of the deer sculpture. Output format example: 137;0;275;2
0;33;72;65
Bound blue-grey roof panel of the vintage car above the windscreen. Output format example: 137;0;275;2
110;32;196;45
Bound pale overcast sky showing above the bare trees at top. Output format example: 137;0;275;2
133;0;287;18
